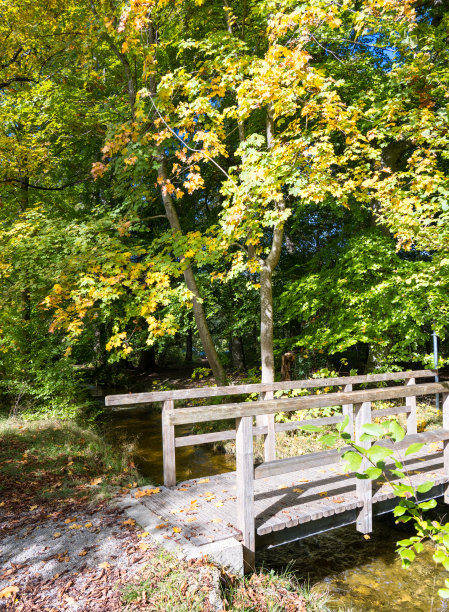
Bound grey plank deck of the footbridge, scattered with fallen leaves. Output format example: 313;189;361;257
140;443;449;546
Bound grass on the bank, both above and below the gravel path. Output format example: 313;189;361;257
0;418;328;612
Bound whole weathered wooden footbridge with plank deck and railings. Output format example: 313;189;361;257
106;370;449;571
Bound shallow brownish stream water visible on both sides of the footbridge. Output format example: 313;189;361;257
105;407;449;612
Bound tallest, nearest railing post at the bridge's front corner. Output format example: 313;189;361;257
235;416;256;572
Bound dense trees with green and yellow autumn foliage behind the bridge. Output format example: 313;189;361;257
0;0;447;412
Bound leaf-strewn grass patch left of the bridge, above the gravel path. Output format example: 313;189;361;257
0;418;147;510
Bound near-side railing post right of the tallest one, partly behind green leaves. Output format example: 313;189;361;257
355;402;373;533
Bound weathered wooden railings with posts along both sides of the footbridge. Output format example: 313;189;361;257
106;370;449;568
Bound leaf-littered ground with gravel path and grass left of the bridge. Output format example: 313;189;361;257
0;419;327;612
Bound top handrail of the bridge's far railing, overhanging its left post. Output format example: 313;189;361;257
105;370;438;407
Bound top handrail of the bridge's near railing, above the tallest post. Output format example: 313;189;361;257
168;383;449;425
